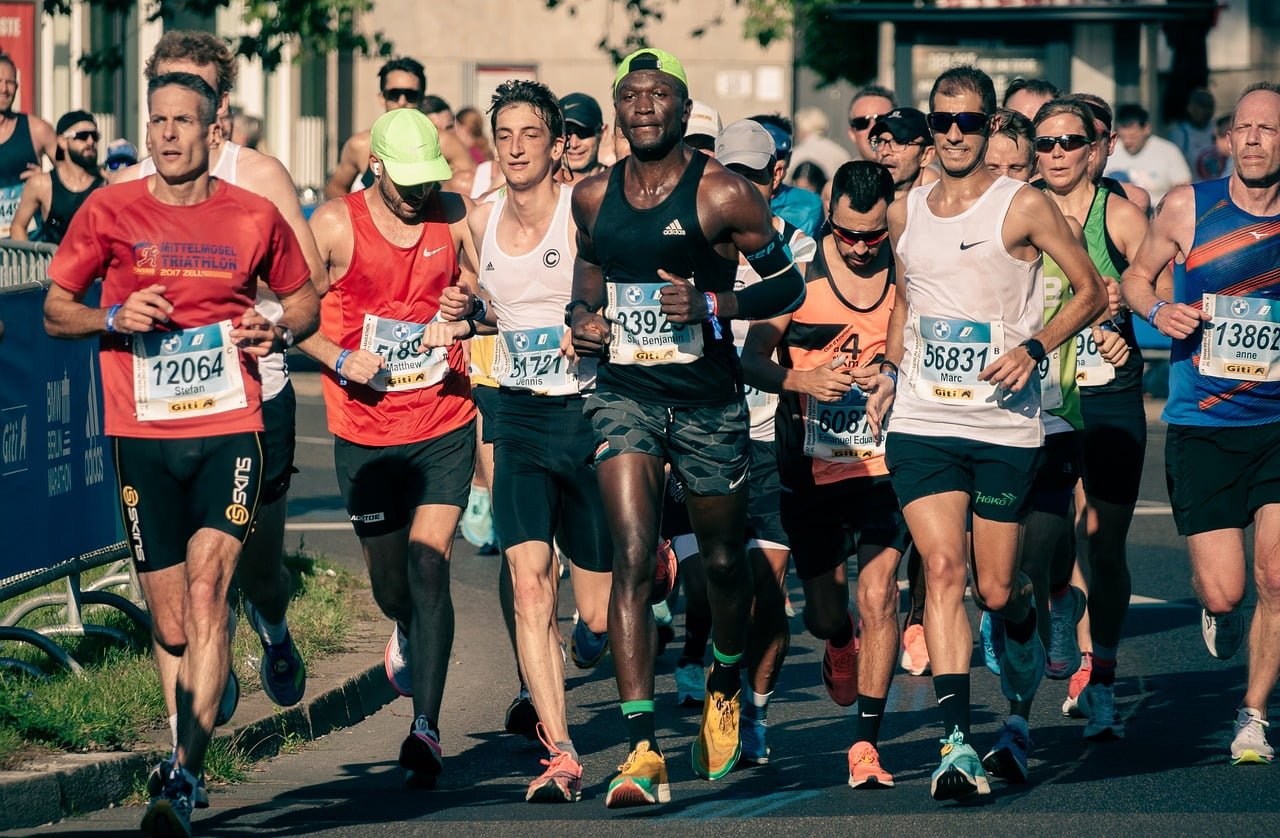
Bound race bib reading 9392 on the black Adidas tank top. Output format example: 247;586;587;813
604;283;703;366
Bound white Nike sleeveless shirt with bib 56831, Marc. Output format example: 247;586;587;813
888;177;1044;448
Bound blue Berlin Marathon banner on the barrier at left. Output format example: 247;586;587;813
0;287;123;580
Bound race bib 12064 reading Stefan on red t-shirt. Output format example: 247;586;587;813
133;320;248;422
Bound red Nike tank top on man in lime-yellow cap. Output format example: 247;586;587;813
320;189;476;447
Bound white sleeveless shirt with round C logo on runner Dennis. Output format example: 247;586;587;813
480;184;596;390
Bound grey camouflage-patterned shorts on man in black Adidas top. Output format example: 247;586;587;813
584;393;751;495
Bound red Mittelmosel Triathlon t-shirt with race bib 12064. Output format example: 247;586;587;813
49;178;311;439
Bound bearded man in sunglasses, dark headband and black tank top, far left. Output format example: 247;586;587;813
9;110;106;244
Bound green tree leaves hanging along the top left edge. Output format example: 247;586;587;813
41;0;392;73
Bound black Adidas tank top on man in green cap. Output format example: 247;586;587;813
591;152;742;407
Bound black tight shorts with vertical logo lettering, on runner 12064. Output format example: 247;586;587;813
113;434;262;573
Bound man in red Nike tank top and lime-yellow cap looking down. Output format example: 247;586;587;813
300;109;476;787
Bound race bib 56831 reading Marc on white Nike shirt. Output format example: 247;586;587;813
911;315;1005;404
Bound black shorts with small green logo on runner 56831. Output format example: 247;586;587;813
884;432;1042;523
